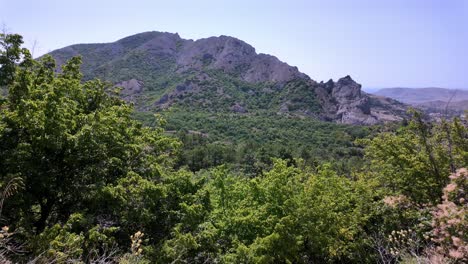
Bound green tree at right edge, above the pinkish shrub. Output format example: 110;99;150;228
360;112;468;203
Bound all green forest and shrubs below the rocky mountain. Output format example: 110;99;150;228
0;34;468;264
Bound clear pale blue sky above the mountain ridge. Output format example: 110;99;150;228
0;0;468;89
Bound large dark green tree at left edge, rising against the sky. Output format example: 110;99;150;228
0;35;178;233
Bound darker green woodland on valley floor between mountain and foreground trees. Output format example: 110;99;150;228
157;109;373;176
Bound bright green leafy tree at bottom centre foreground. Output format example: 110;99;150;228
160;160;373;263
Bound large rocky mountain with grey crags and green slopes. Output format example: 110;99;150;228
50;32;406;124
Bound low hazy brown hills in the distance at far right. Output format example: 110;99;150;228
374;88;468;115
